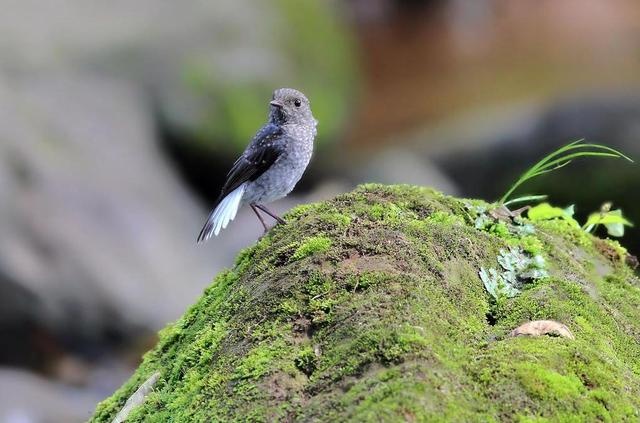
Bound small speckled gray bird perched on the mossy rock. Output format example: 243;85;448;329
198;88;318;242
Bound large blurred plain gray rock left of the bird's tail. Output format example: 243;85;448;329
0;74;224;362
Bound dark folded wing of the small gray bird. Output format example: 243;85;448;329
220;125;283;199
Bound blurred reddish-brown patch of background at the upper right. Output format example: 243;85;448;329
345;0;640;147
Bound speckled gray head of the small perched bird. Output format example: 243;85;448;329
269;88;317;127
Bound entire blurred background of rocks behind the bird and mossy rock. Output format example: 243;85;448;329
0;0;640;423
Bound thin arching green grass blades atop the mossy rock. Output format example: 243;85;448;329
500;139;633;205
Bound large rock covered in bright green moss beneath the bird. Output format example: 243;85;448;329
93;185;640;422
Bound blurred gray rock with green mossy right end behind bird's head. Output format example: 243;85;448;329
0;0;353;153
